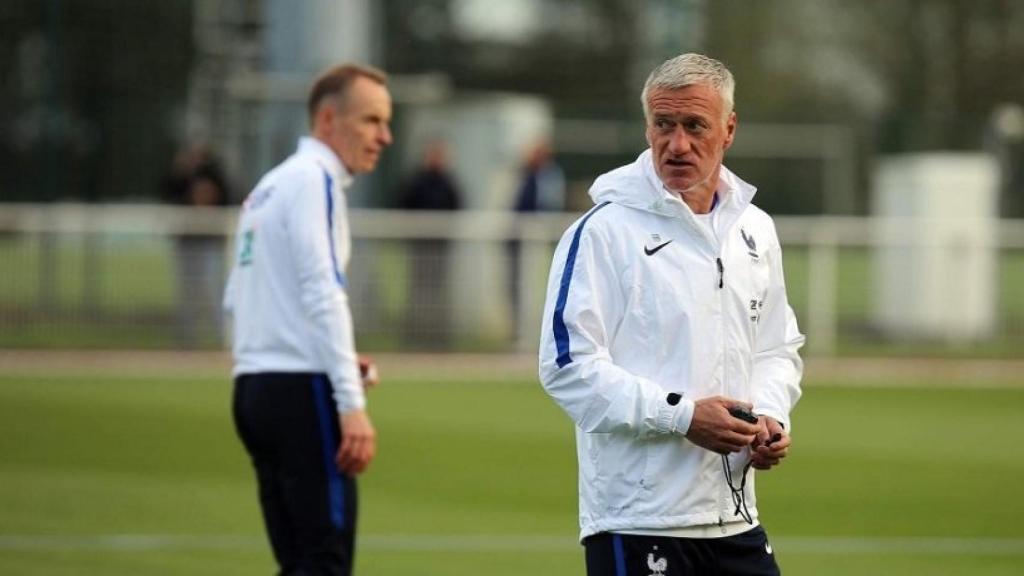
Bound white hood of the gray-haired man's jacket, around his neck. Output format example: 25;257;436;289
590;149;757;224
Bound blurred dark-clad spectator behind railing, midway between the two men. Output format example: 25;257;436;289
398;140;460;347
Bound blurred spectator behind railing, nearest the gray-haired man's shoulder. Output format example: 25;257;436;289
508;140;565;341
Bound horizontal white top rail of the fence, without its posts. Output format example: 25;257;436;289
0;203;1024;243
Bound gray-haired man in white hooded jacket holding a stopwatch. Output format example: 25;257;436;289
540;54;804;576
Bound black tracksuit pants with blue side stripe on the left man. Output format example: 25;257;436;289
232;373;356;576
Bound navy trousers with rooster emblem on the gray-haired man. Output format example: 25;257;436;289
583;526;780;576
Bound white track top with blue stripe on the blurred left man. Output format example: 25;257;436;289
224;137;366;412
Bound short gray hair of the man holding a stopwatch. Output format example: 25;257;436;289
640;52;736;121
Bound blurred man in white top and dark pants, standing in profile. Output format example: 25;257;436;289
224;65;391;574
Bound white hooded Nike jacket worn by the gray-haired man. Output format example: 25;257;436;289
540;150;804;539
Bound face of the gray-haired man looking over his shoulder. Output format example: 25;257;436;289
646;84;736;198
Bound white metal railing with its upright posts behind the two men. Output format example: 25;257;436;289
0;204;1024;355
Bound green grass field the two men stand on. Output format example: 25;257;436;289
0;364;1024;576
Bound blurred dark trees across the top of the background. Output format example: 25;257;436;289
0;0;1024;216
